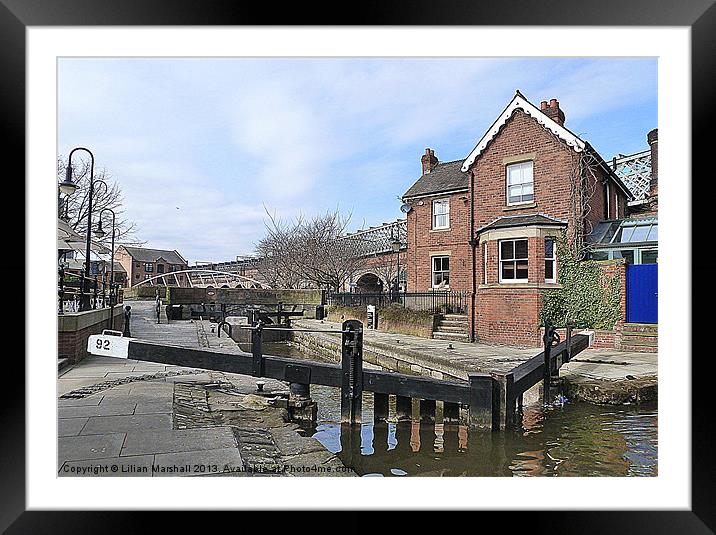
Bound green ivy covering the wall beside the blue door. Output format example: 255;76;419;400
540;232;621;330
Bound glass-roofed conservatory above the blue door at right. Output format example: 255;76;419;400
587;217;659;264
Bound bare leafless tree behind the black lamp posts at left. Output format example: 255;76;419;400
57;156;143;247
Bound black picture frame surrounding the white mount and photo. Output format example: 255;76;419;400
0;0;704;535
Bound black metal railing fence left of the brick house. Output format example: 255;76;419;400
328;290;469;314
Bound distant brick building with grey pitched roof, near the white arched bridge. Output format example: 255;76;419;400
114;245;189;286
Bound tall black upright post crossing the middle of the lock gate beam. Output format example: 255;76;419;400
341;320;363;424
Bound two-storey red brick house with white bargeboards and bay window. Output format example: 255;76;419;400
403;91;634;345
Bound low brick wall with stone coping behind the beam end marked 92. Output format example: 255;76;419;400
57;306;124;364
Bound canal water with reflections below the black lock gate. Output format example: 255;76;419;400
255;344;658;476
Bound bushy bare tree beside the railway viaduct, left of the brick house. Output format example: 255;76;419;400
256;210;364;291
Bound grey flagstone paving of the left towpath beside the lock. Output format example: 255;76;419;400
58;302;355;477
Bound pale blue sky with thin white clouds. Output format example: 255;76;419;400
57;58;657;264
